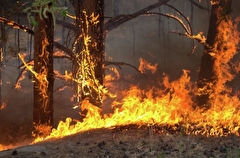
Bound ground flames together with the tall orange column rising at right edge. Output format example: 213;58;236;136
29;13;240;142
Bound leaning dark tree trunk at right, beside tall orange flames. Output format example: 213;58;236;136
196;0;232;108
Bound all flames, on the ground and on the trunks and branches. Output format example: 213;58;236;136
0;0;240;154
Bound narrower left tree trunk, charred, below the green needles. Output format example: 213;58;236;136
33;13;54;136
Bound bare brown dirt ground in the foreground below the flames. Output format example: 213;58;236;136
0;125;240;158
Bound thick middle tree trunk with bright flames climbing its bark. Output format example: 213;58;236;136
72;0;104;106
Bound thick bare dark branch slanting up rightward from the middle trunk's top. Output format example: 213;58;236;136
104;0;169;32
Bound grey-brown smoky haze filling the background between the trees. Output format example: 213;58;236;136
0;0;240;144
